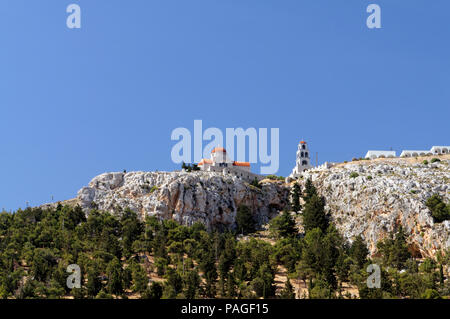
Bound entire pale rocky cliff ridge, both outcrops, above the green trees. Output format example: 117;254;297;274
75;155;450;256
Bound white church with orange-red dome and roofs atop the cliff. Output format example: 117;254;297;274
198;147;262;180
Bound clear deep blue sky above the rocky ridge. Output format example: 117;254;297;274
0;0;450;210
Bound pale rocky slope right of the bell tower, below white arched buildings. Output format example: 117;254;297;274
300;159;450;256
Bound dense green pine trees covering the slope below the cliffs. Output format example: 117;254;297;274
0;180;450;299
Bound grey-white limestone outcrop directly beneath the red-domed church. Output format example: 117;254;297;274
77;172;289;229
